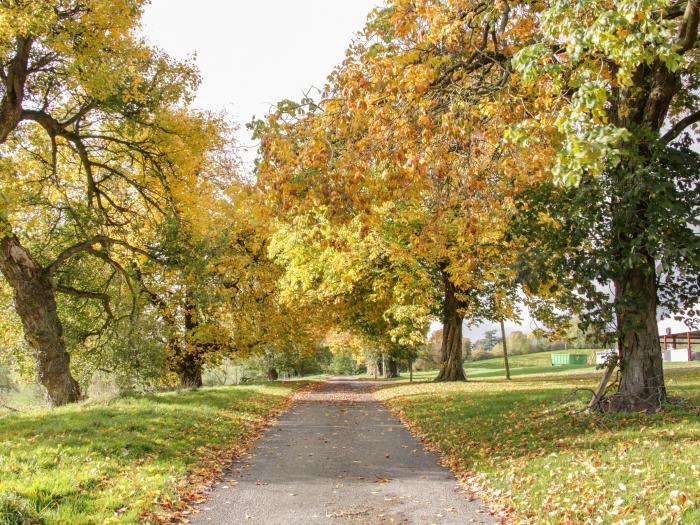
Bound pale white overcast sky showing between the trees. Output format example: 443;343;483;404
143;0;683;340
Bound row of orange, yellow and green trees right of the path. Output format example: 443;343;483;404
256;0;700;410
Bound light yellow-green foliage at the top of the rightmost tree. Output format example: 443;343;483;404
513;0;692;185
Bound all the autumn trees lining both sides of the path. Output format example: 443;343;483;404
0;0;700;410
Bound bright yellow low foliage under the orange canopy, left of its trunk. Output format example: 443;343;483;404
270;207;432;374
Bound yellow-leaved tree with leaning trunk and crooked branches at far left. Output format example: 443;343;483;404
0;0;217;406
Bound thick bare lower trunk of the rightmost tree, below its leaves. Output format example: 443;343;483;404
612;262;666;411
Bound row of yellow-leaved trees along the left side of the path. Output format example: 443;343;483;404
0;0;328;406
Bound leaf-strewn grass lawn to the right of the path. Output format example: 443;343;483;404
378;366;700;524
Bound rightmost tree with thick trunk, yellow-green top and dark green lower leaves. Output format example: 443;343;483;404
513;1;700;410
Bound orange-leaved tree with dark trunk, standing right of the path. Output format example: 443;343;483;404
259;0;545;381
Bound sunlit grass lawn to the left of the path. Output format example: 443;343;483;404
0;382;301;525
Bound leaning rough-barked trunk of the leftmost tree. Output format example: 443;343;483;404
0;233;80;407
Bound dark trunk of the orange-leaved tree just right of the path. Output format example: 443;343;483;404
435;271;467;381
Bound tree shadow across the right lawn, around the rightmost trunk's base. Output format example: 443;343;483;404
380;366;700;468
